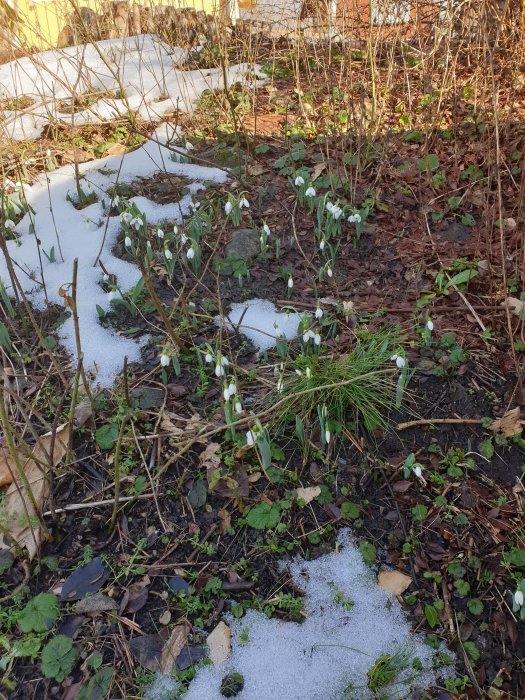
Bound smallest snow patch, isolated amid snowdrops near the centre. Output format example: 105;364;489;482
217;299;301;350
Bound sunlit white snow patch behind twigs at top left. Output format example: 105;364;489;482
0;34;264;140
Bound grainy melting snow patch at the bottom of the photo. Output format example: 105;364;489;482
148;530;453;700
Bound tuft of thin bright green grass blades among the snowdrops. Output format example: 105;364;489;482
271;328;406;434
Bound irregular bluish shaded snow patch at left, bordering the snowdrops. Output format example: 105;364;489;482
0;125;227;386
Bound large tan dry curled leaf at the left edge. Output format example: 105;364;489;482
0;410;91;559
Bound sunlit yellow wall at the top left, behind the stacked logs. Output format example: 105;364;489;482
15;0;220;49
